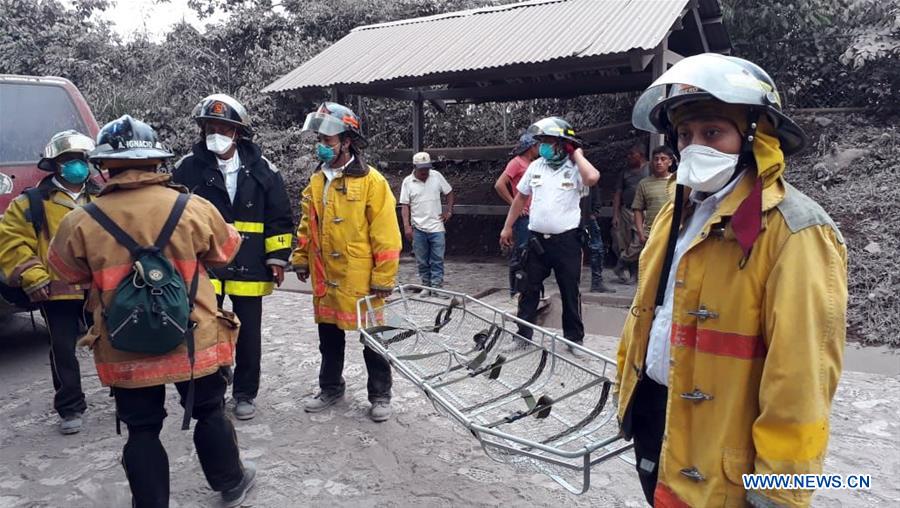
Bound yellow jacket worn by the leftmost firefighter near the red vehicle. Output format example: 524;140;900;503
0;175;99;300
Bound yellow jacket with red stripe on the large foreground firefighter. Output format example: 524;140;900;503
617;178;847;506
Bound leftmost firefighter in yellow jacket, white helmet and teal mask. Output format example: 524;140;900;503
0;130;99;434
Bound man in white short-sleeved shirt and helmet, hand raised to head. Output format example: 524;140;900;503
500;117;600;354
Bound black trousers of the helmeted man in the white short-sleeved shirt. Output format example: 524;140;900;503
517;229;584;343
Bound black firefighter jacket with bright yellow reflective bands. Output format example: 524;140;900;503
172;140;294;296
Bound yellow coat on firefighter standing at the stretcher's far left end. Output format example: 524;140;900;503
291;161;402;330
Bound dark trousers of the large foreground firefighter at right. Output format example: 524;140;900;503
631;374;668;506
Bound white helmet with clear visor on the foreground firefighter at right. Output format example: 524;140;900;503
631;53;806;155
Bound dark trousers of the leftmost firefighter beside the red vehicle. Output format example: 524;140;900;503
41;300;87;417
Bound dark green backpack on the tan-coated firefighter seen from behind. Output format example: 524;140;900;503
84;194;200;430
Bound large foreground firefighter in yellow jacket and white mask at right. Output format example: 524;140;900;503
617;54;847;507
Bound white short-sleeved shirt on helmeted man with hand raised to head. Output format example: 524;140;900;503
516;157;588;235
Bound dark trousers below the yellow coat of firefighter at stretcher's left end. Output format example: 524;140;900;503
319;323;392;403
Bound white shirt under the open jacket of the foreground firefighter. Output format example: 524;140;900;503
646;173;746;386
